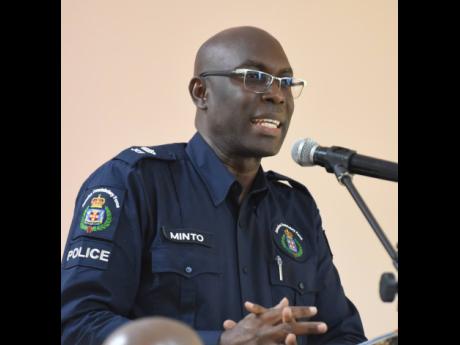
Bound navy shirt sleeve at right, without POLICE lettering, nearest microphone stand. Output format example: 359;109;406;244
308;204;367;345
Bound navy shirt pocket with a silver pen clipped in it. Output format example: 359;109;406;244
269;254;318;306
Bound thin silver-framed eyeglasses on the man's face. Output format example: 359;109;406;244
200;68;307;98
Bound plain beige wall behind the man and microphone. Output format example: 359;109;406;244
61;0;398;337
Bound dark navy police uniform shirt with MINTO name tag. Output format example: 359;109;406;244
61;133;366;345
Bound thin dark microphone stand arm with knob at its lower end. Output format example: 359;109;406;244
326;163;398;302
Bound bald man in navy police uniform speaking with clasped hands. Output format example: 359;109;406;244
61;27;366;345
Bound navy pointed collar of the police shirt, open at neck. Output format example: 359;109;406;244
185;132;268;206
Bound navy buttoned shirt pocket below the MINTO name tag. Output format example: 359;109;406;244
151;243;222;327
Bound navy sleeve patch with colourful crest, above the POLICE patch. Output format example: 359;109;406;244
72;186;125;241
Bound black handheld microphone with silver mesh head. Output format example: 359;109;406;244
291;138;398;182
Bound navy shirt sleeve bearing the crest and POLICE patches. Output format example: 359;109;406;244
61;161;147;345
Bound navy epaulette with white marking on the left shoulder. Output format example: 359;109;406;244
113;143;185;165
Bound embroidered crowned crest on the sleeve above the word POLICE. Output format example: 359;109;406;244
80;194;112;233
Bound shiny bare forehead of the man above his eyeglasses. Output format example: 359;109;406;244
205;37;290;74
